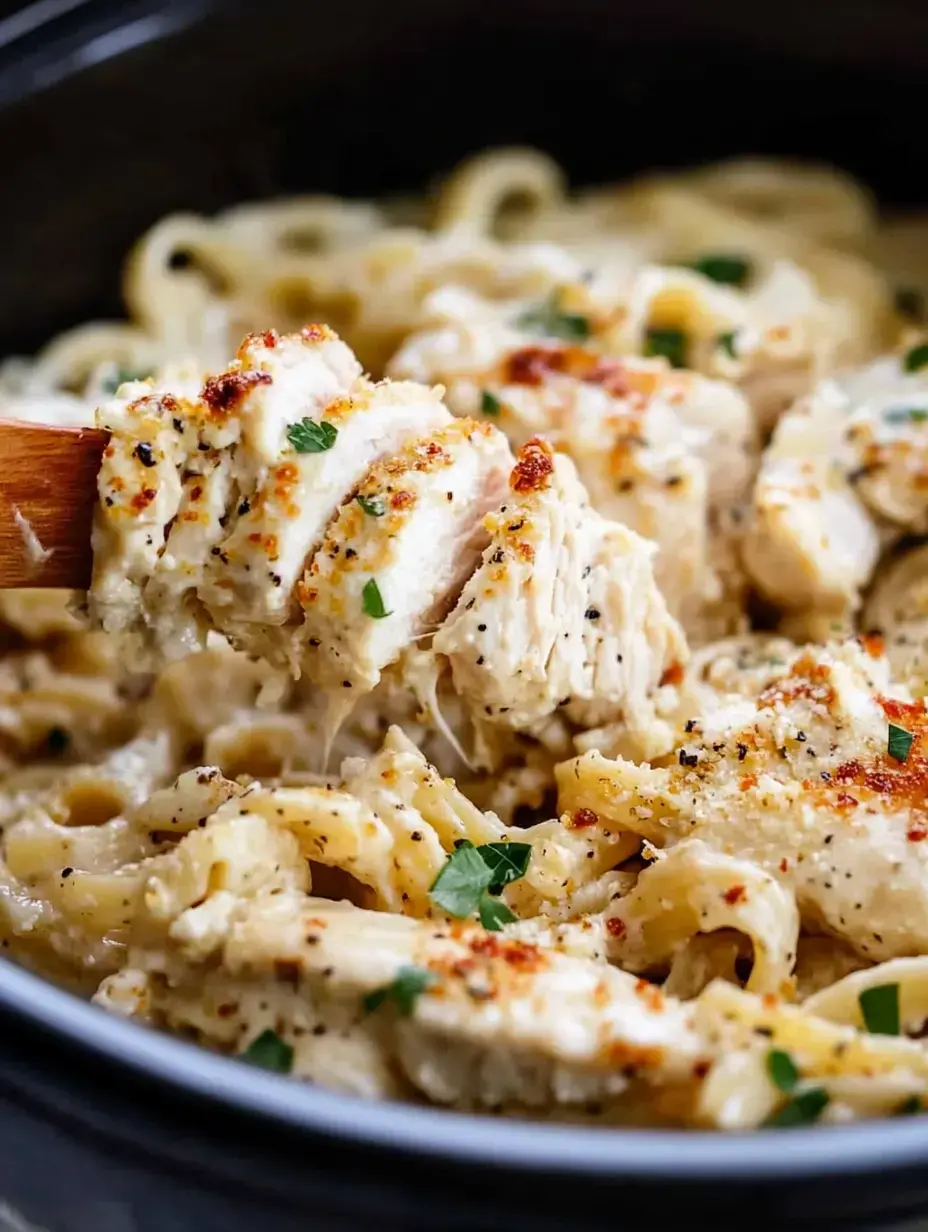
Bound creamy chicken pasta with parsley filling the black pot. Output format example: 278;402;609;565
0;149;928;1130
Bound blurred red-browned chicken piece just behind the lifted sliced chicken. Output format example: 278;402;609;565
391;293;757;636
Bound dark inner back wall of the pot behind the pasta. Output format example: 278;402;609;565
0;0;928;354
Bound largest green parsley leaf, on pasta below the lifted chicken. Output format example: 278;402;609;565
429;839;531;933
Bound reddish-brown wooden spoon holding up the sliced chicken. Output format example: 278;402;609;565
0;419;110;590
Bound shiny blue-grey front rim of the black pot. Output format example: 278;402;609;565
0;960;928;1183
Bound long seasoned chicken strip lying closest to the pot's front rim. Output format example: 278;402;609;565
97;891;709;1108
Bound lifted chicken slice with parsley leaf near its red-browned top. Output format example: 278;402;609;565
198;326;450;649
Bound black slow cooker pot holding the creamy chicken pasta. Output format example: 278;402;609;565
0;0;928;1232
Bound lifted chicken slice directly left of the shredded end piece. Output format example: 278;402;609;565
298;419;513;702
